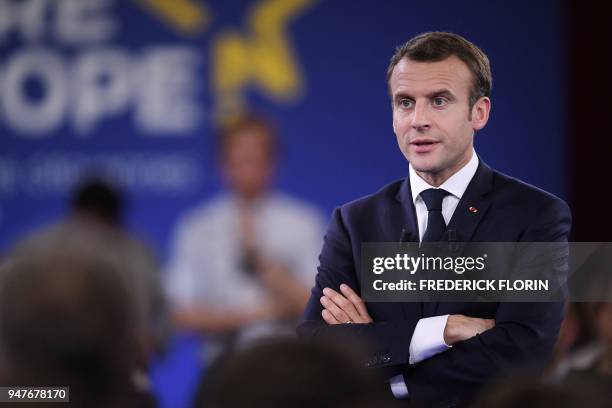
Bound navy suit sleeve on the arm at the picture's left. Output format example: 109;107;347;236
297;209;417;367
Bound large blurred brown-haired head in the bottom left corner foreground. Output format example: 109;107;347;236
0;244;135;407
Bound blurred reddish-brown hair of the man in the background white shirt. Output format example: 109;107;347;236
217;113;278;157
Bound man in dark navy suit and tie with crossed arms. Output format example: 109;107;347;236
298;32;571;406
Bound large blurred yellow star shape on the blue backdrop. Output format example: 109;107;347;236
211;0;315;122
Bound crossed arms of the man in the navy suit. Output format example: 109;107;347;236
297;200;571;396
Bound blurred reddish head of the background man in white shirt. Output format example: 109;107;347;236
219;115;277;199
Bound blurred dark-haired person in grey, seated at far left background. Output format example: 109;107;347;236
15;176;169;375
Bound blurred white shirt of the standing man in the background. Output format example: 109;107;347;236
165;193;325;360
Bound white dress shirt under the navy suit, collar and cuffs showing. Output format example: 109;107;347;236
389;149;478;398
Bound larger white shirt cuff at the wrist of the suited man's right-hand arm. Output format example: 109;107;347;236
408;315;452;365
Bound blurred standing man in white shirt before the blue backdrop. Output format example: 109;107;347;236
167;115;323;362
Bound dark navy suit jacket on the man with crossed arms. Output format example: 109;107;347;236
297;160;571;406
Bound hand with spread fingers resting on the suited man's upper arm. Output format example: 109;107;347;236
321;283;374;324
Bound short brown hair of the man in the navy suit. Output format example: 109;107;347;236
387;31;493;108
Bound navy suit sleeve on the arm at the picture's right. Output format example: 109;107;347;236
404;199;571;403
